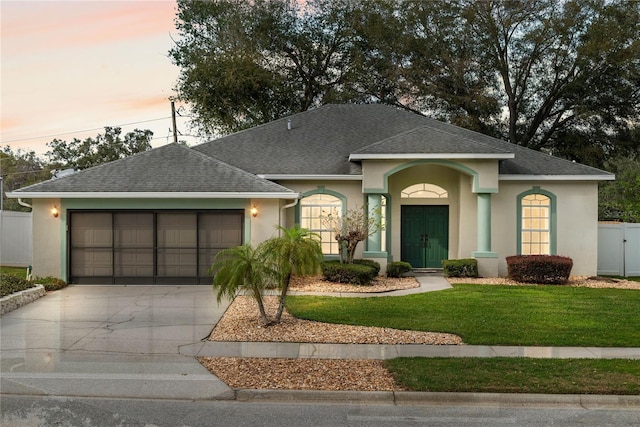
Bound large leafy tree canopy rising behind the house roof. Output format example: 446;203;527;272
170;0;640;167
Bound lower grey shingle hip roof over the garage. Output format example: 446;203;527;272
13;144;296;197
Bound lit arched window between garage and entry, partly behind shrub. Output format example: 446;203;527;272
300;194;342;255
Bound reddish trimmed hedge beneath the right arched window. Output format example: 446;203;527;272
507;255;573;285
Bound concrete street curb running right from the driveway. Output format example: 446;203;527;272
235;389;640;410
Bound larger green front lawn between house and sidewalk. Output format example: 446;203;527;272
287;285;640;347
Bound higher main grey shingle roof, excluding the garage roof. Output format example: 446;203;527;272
194;104;611;177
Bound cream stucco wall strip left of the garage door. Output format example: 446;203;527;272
31;199;66;279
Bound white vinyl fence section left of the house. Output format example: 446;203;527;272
0;211;33;267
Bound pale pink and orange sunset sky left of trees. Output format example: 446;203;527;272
0;0;196;154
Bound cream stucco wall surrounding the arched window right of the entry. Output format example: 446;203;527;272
491;181;598;276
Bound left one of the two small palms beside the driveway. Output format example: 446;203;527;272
209;244;275;325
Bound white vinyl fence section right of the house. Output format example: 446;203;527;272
598;222;640;277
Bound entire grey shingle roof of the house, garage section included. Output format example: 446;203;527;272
12;104;612;198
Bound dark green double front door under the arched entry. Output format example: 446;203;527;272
400;205;449;268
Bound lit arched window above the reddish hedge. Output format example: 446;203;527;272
518;192;555;255
